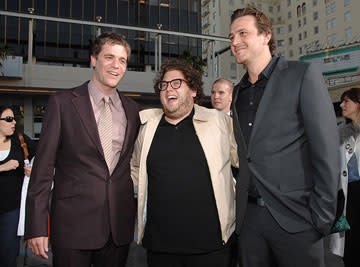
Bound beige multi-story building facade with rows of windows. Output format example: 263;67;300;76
201;0;360;85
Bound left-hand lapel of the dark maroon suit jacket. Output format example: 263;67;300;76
72;83;104;157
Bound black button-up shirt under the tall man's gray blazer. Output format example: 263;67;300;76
235;57;279;197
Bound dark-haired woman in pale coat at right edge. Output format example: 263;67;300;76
327;88;360;267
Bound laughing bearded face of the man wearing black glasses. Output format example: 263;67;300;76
160;70;196;124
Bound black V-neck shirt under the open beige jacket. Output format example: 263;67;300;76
143;112;222;253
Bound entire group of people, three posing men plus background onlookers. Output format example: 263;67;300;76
0;6;360;267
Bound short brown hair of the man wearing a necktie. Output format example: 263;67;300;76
91;32;131;61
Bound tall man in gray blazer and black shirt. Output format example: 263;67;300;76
229;7;339;267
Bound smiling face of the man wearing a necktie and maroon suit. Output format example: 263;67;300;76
91;43;128;95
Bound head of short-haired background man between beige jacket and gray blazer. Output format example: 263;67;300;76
211;78;234;115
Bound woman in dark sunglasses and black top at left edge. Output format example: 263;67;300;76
0;106;36;267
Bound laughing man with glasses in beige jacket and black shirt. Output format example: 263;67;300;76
131;60;238;267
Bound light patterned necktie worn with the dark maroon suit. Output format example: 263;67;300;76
98;96;112;168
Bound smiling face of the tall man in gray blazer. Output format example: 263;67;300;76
229;15;271;66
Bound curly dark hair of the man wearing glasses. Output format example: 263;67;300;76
154;59;204;104
